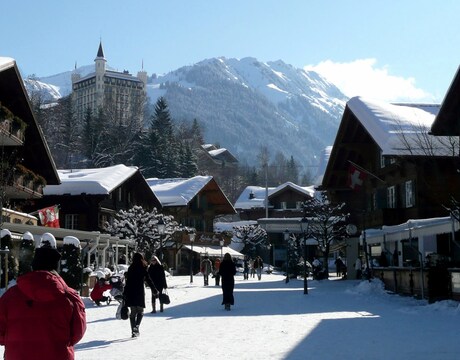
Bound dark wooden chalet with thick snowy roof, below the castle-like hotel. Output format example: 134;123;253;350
36;165;161;231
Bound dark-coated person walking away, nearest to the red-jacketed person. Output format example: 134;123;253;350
123;253;158;337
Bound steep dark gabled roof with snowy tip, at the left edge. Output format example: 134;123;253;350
0;57;59;184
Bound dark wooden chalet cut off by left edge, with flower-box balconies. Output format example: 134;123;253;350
0;57;59;211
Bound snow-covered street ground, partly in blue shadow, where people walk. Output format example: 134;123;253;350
0;273;460;360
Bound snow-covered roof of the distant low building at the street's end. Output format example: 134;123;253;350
235;181;315;210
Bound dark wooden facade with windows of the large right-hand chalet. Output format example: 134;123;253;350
321;97;460;228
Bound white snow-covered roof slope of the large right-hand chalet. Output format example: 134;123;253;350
347;97;452;156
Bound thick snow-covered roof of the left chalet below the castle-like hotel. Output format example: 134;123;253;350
43;164;138;195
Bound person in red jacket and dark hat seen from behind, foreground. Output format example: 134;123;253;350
0;232;86;360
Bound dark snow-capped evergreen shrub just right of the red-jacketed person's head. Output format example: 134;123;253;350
60;236;83;290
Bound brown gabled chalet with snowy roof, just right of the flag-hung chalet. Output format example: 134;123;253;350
147;176;235;273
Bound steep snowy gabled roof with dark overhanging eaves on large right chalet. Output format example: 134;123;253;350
322;97;458;188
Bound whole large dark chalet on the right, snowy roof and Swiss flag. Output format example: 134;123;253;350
321;97;460;295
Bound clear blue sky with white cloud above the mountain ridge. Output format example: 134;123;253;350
0;0;460;102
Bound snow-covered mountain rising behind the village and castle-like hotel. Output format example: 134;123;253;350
22;57;347;174
